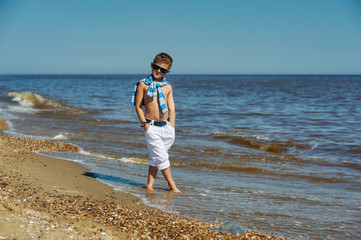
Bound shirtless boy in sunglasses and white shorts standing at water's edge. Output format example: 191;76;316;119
132;53;180;193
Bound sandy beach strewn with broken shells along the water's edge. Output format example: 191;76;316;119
0;118;292;239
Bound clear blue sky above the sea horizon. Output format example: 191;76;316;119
0;0;361;74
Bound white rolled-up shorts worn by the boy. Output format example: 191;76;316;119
144;122;175;170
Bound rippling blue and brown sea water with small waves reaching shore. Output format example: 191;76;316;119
0;75;361;239
